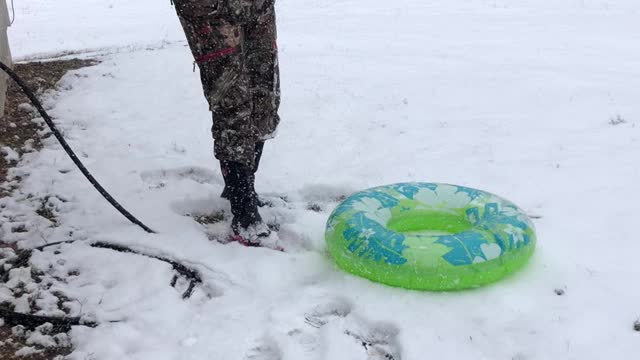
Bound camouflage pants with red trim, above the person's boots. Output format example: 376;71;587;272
174;0;280;167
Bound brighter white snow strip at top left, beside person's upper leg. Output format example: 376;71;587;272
9;0;184;60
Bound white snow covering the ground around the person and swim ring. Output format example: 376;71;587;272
5;0;640;360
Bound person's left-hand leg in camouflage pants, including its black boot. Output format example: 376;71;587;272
174;9;268;240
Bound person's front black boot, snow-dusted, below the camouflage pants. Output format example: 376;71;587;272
221;161;270;244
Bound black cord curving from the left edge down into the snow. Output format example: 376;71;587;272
0;61;155;234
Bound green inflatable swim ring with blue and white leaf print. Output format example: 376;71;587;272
326;183;536;291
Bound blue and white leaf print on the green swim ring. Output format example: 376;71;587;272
327;183;531;266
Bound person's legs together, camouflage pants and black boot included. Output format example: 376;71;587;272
176;0;280;240
